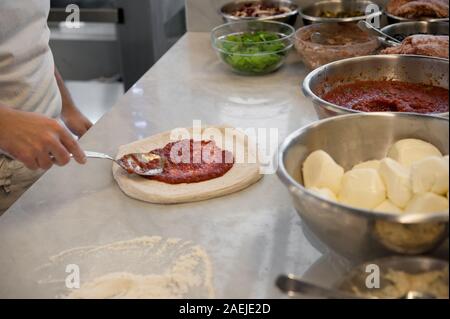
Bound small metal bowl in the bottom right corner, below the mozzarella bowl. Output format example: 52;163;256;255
334;256;449;299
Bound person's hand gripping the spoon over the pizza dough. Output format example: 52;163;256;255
0;106;86;170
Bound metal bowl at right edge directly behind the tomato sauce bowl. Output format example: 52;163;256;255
381;21;449;41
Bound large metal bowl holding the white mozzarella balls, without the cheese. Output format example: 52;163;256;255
278;113;449;260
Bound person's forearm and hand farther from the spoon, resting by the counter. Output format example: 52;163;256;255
55;66;92;137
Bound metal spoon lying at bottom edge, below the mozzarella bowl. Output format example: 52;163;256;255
276;275;436;299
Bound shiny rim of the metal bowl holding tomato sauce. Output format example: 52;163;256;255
302;54;449;117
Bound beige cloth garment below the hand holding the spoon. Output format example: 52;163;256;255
0;155;44;216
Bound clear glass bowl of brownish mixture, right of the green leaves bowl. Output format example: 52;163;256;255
295;23;380;69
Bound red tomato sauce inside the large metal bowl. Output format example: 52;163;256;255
323;81;449;114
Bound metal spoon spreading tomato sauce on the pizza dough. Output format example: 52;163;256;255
84;151;164;176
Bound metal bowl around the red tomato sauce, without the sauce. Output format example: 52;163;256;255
303;55;449;118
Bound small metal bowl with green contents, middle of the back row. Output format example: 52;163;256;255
300;0;383;25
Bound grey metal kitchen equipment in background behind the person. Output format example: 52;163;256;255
49;0;185;90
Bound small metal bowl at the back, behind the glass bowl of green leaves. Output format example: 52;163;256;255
220;0;298;26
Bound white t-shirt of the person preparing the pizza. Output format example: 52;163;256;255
0;0;61;118
